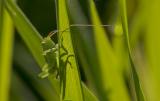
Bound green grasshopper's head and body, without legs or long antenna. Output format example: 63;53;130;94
39;31;59;78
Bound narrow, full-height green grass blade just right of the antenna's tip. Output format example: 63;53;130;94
119;0;145;101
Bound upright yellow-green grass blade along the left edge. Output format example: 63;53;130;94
0;9;14;101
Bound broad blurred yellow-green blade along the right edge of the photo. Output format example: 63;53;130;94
143;0;160;101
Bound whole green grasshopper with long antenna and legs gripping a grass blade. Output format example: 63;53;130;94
39;24;111;78
